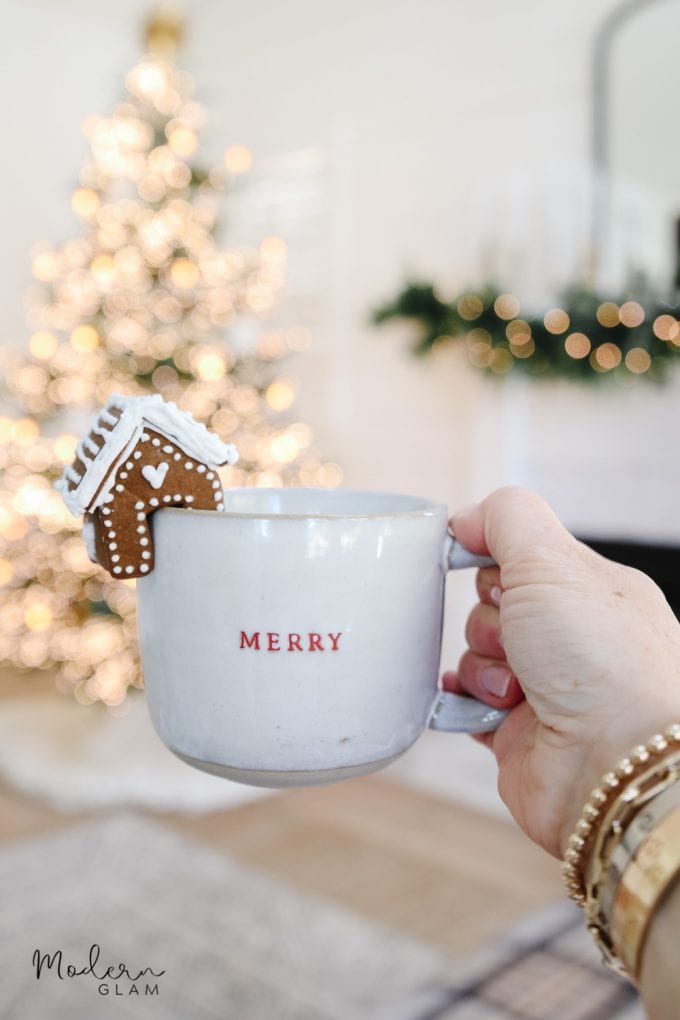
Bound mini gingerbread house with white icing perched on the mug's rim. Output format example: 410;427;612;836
55;394;239;577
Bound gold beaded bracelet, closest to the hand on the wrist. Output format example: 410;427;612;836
562;722;680;907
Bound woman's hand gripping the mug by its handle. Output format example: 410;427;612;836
443;489;680;856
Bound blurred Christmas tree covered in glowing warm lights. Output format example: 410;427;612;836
0;9;342;711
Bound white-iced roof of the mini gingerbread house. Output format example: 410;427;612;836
55;394;239;516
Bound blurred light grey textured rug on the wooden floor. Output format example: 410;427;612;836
0;812;642;1020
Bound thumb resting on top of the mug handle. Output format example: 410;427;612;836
451;487;575;566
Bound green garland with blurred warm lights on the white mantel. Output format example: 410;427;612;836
372;283;680;385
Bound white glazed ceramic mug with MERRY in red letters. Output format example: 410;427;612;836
137;489;505;786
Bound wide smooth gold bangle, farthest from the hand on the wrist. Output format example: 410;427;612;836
611;808;680;980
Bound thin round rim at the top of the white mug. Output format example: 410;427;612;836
156;486;448;520
